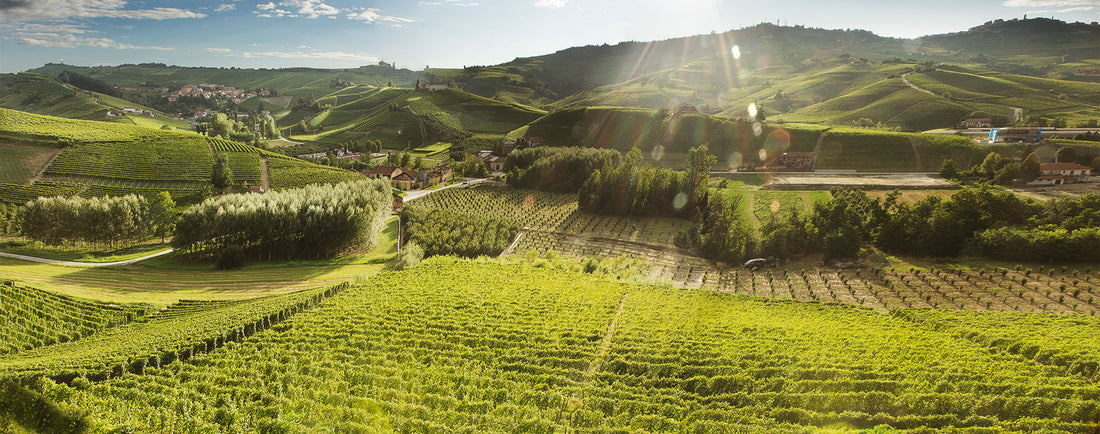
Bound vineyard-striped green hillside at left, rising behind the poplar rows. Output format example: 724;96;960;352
0;109;360;204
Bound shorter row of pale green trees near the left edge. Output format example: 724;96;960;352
15;191;176;247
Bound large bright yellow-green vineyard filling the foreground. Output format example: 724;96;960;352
10;258;1100;433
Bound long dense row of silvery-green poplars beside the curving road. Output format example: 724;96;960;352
172;180;393;259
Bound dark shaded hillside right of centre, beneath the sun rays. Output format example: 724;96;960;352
508;107;989;171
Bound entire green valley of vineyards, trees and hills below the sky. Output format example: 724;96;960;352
0;11;1100;433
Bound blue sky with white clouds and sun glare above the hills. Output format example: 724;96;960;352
0;0;1100;73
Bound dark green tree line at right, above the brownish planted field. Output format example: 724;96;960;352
758;187;1100;261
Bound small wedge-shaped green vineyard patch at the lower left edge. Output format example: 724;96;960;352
0;281;143;354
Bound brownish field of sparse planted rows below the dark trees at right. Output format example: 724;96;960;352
701;261;1100;316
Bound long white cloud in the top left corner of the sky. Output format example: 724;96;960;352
0;0;206;21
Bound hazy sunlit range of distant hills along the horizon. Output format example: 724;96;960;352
10;18;1100;131
